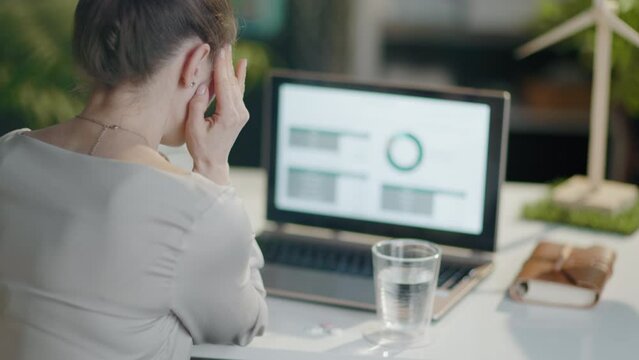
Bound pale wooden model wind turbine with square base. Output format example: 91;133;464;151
516;0;639;212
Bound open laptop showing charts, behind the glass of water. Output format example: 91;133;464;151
257;71;510;320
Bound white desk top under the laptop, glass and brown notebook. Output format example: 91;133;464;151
182;168;639;360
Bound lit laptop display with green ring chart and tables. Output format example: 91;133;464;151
270;72;510;252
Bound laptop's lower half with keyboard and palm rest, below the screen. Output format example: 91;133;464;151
258;233;493;320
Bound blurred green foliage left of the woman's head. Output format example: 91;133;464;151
0;0;82;128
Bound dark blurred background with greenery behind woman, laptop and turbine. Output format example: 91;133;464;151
0;0;639;183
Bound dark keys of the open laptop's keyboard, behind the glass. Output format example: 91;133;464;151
258;236;474;289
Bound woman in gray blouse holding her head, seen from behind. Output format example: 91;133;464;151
0;0;266;360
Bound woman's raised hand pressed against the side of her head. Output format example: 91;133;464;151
186;45;249;185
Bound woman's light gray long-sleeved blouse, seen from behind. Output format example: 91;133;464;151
0;130;267;360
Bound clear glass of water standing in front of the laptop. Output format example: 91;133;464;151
365;239;441;347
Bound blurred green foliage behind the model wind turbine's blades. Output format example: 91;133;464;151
539;0;639;117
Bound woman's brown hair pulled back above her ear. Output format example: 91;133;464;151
73;0;237;86
